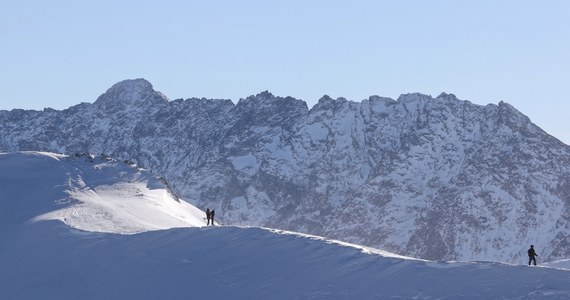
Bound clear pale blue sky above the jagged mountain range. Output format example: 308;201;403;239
0;0;570;144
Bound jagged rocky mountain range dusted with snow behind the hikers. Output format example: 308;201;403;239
0;79;570;262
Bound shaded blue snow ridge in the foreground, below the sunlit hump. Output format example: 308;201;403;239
0;222;570;299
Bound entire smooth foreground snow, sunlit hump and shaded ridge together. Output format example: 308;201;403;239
0;152;570;299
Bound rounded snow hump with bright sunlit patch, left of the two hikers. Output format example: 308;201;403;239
0;152;204;234
